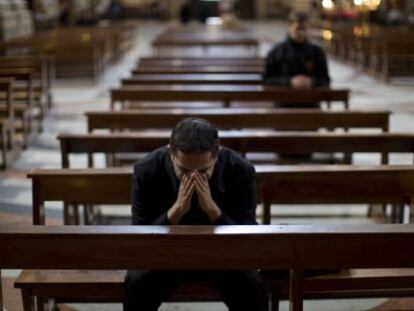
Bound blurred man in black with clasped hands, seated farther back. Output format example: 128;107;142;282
263;11;330;108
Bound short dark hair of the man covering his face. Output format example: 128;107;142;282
170;118;219;155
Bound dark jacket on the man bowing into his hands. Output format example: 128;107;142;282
132;146;257;225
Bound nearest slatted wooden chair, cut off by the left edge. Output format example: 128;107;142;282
0;78;15;169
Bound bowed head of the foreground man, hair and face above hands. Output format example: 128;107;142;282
170;118;219;180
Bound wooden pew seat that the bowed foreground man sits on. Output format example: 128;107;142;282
14;269;414;310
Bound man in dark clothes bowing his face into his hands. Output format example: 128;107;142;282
124;118;267;311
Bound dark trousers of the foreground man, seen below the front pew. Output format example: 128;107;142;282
124;270;268;311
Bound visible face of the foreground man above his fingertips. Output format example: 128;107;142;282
171;151;216;180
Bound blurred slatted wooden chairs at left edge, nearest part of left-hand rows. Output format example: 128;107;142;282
0;55;55;169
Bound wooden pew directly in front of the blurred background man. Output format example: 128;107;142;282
111;85;349;110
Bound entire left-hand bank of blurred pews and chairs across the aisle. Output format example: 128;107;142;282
0;23;139;169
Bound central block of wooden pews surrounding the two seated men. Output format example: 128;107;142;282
0;22;414;311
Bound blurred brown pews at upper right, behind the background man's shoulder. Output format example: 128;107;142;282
314;22;414;81
